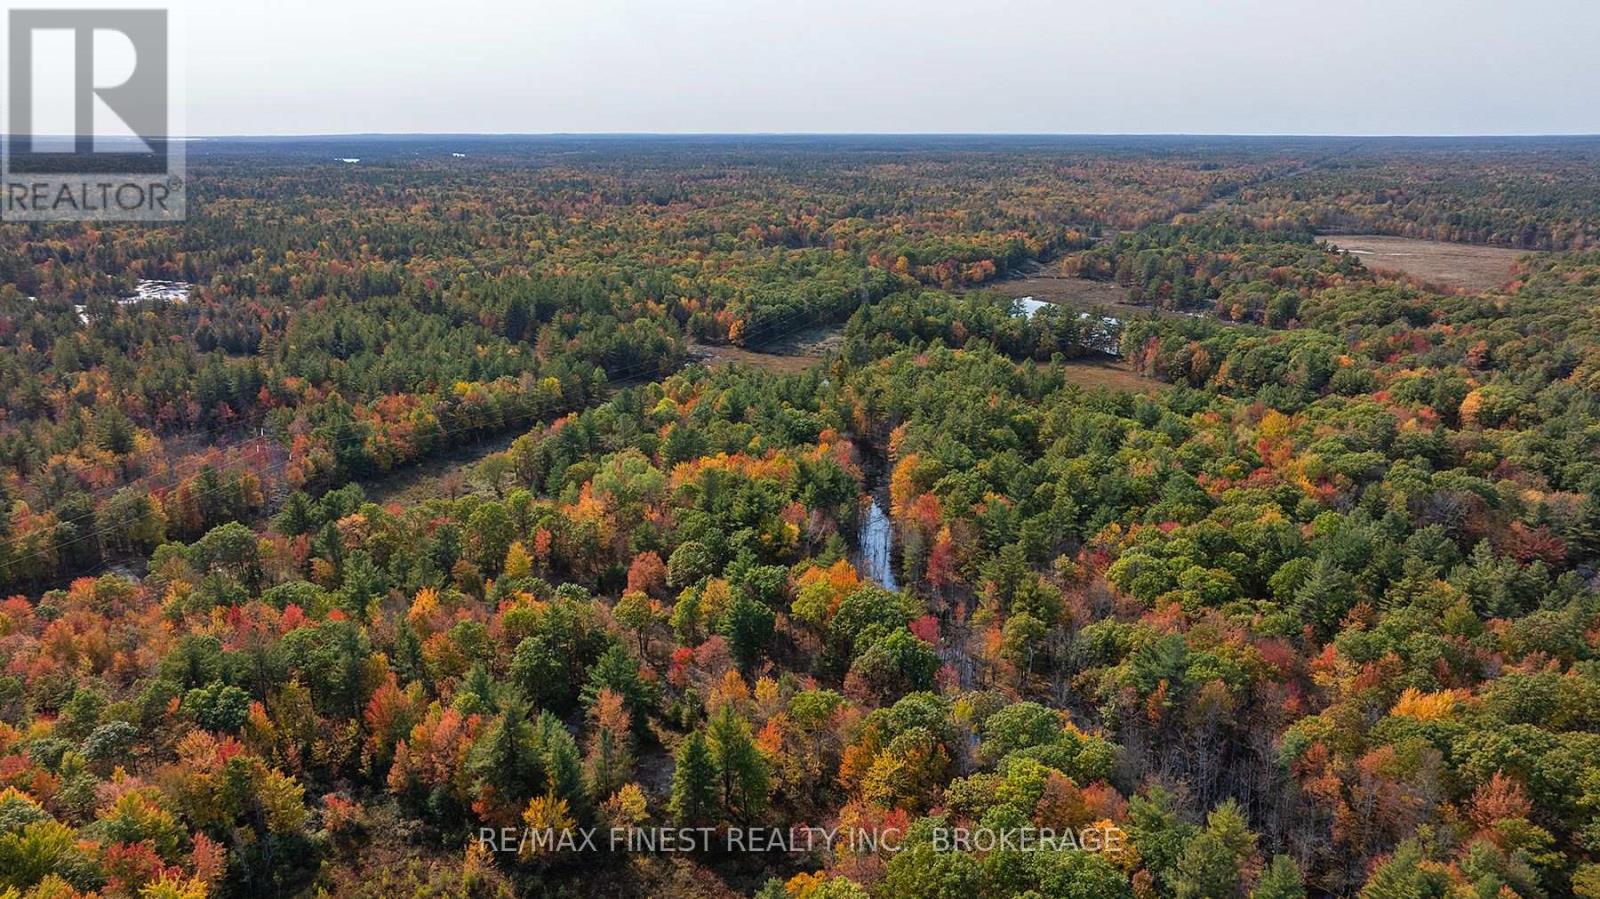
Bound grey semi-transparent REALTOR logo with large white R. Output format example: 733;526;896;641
0;10;184;221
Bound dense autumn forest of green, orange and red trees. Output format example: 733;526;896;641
0;138;1600;899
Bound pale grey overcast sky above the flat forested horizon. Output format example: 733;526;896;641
172;0;1600;134
